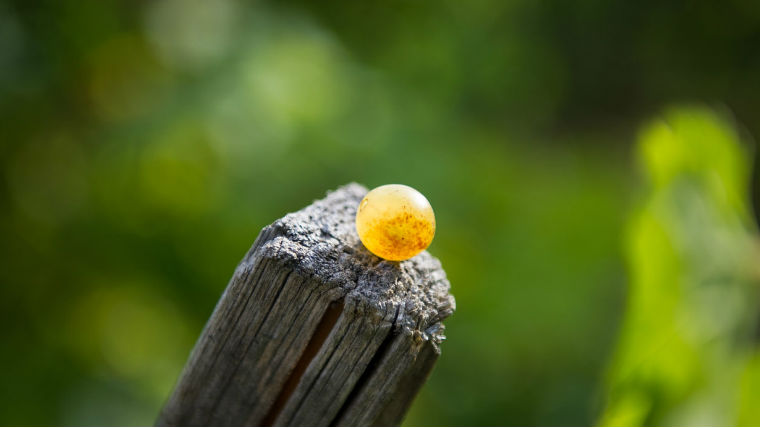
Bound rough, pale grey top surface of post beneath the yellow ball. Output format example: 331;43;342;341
255;183;455;344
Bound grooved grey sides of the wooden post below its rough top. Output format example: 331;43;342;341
157;183;454;425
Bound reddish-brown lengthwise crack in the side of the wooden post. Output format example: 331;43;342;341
261;299;344;426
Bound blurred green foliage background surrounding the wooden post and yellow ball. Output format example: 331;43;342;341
0;0;760;425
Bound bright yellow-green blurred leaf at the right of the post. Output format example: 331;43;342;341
602;109;760;425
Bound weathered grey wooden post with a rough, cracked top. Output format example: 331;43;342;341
158;184;454;426
